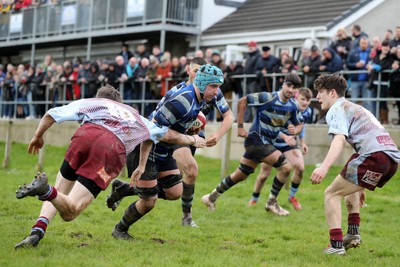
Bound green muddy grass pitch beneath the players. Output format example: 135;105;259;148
0;143;400;267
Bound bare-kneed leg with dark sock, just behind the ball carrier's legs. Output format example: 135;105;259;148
173;146;198;227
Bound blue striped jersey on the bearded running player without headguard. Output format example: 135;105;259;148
247;92;303;144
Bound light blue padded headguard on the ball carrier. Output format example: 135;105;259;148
194;64;224;94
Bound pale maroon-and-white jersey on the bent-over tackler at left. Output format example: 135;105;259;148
48;98;168;154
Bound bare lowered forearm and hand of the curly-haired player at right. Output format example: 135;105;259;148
311;134;346;184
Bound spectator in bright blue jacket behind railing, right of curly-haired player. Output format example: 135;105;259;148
346;37;374;112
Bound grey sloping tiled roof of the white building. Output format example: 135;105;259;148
203;0;373;35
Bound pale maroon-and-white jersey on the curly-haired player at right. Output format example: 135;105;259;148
326;97;400;162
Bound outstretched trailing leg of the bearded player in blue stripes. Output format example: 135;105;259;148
201;157;258;211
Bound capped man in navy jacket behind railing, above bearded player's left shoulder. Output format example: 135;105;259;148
256;46;279;92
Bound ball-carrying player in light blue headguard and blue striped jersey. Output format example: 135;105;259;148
112;64;231;240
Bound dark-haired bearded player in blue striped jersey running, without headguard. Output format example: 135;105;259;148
202;73;302;216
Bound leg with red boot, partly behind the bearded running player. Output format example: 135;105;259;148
284;148;304;210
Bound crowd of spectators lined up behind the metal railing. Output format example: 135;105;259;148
0;23;400;124
